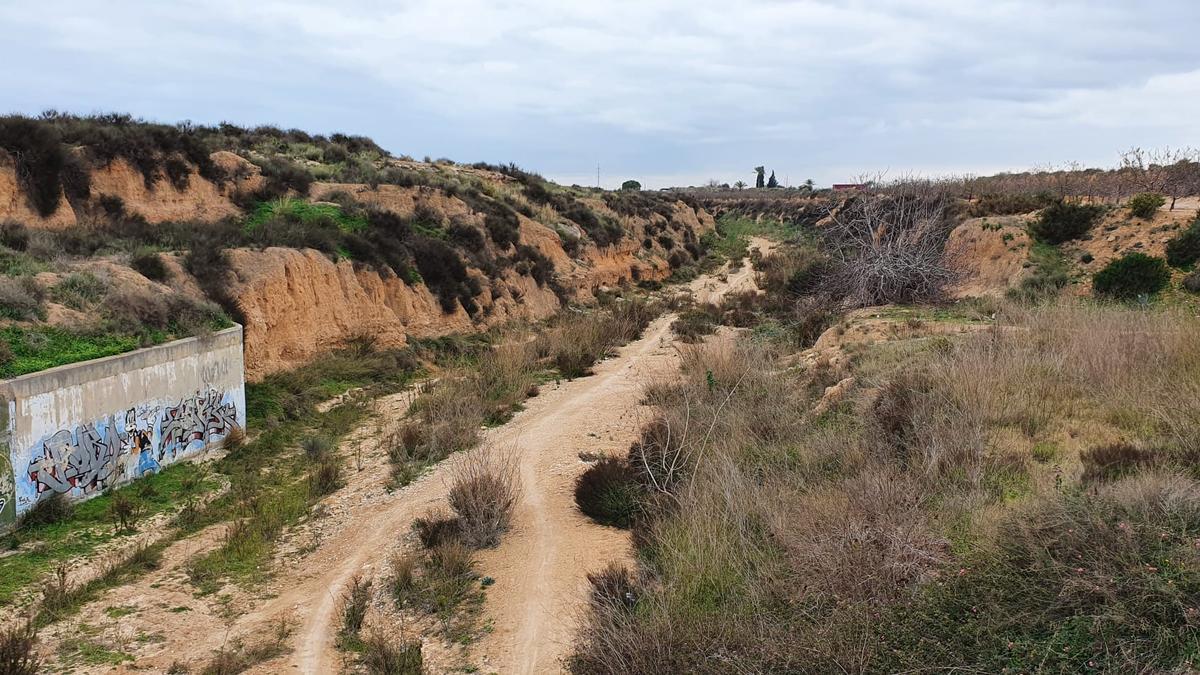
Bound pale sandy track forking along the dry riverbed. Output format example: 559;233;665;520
42;239;772;675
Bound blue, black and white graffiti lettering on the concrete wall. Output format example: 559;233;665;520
17;388;239;512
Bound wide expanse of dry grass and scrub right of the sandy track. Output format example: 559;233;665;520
570;303;1200;673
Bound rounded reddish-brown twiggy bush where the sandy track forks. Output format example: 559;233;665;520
449;447;520;548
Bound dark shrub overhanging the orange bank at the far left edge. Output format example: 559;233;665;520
0;115;67;217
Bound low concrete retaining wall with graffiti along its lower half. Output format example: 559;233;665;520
0;325;246;530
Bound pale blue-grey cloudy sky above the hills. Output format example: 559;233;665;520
0;0;1200;187
